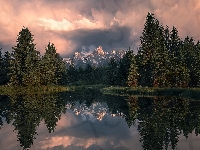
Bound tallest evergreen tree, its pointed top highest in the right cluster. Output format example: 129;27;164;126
136;13;168;87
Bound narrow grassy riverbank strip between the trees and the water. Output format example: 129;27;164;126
0;84;200;99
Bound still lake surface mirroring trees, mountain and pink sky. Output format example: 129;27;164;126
0;89;200;150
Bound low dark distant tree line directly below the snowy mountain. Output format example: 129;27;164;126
67;48;133;86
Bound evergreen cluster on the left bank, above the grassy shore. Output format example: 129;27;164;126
0;28;66;86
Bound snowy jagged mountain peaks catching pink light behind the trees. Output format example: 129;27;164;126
63;46;126;68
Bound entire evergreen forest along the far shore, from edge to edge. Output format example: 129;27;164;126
0;13;200;88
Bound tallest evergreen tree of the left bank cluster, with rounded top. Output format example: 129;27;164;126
10;28;39;86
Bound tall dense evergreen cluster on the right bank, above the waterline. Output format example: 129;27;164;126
127;13;200;87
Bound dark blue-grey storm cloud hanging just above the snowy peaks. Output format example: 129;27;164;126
57;26;138;56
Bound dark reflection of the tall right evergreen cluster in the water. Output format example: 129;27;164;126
127;97;200;150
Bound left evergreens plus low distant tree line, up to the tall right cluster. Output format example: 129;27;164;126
0;25;136;86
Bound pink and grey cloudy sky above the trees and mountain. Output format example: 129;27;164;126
0;0;200;58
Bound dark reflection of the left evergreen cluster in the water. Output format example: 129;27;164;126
0;94;66;149
